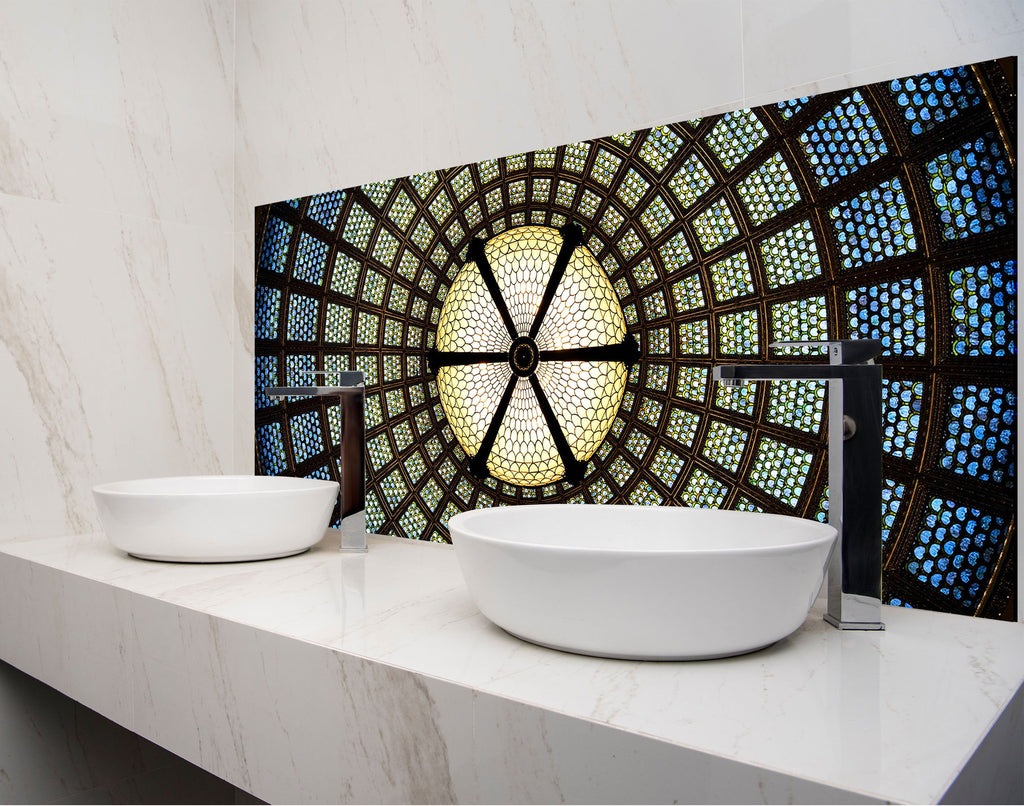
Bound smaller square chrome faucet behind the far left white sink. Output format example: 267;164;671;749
263;370;367;551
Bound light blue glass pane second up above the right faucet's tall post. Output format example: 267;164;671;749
828;177;918;269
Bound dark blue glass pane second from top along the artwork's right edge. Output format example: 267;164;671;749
925;132;1016;241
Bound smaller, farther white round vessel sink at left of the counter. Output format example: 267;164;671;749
92;476;340;562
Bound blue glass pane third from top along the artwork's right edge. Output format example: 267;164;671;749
949;260;1017;355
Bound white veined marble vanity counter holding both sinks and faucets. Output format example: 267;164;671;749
0;533;1024;803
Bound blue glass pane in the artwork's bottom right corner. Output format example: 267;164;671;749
904;498;1006;609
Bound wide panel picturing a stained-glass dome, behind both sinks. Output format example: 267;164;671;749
255;59;1018;619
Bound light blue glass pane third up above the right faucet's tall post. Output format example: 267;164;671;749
800;90;889;187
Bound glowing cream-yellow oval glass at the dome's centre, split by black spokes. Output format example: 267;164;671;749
437;227;626;486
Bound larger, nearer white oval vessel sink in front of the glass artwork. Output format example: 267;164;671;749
449;504;837;661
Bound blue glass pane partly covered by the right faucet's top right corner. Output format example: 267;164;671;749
846;278;928;355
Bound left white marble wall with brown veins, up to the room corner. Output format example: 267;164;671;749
0;0;236;540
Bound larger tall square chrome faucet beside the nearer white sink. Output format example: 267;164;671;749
712;339;885;630
